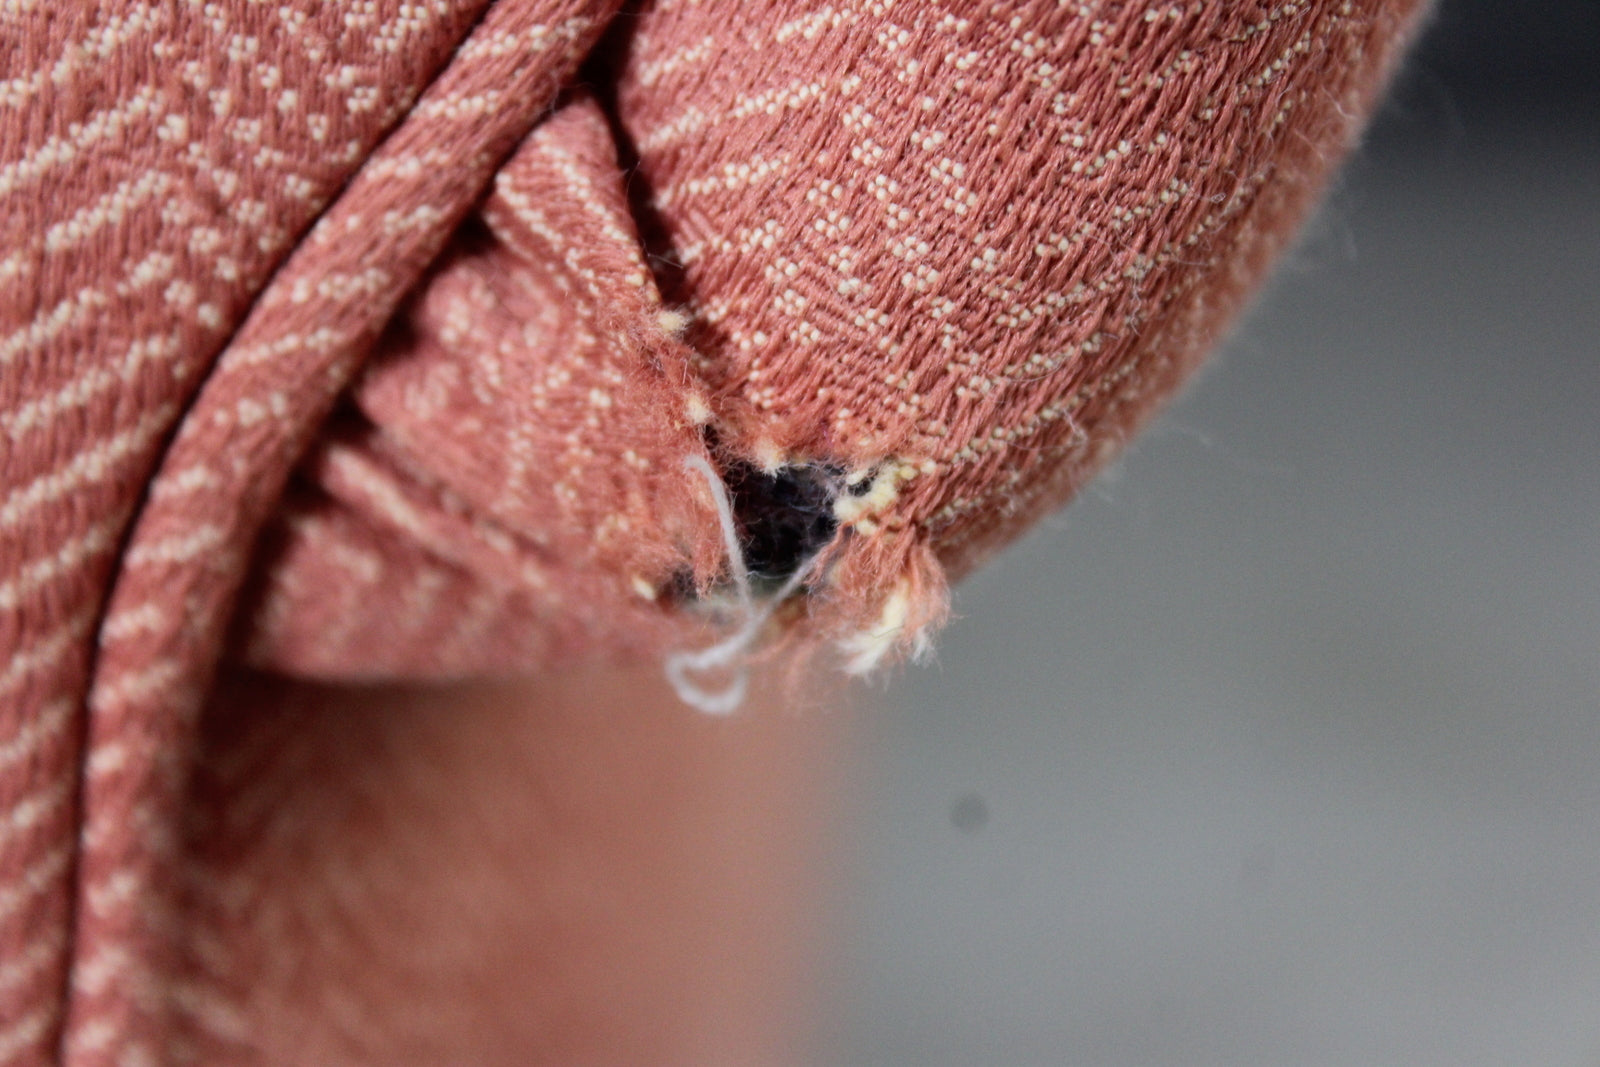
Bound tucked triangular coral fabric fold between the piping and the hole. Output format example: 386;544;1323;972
242;96;722;678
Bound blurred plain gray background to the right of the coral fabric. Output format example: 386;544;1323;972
819;0;1600;1067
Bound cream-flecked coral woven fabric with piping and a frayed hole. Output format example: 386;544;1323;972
0;0;1421;1065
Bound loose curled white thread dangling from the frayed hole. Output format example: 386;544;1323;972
666;456;818;715
